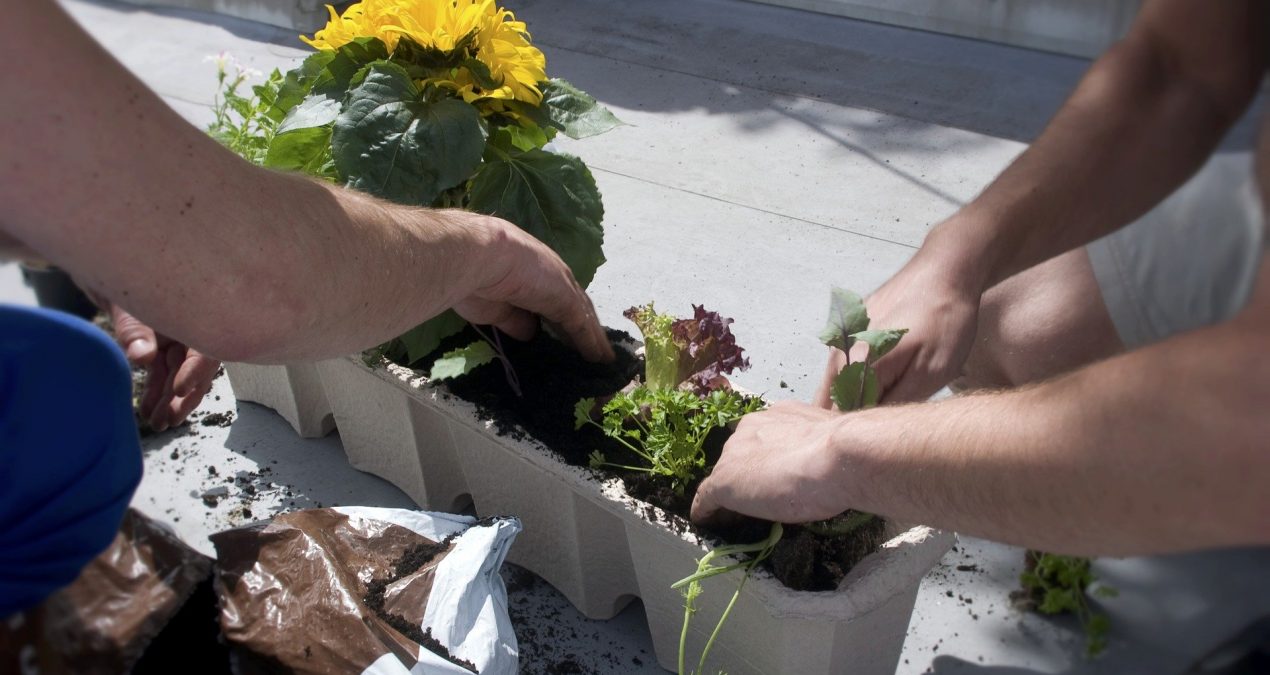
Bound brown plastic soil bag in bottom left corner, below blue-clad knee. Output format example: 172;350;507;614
0;510;212;675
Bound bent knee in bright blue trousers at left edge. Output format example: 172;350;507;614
0;305;141;618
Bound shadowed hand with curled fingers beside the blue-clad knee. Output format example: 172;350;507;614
108;303;221;432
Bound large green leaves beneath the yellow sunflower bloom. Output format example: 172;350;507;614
208;27;621;365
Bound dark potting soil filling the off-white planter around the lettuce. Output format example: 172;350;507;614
415;328;885;591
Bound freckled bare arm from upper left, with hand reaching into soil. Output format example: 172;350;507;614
0;0;610;362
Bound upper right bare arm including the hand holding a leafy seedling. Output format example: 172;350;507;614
818;0;1270;406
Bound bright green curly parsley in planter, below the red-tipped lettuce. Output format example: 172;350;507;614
574;386;762;494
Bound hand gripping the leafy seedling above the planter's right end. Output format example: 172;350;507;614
813;249;982;409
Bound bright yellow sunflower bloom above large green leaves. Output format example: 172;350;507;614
307;0;547;105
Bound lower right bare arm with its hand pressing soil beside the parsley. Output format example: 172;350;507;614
693;256;1270;554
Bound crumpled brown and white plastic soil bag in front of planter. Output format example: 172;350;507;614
212;507;521;675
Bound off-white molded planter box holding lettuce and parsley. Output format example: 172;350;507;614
226;357;954;675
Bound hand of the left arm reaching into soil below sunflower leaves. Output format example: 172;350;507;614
455;217;613;361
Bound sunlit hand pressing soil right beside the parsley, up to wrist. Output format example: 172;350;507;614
692;400;850;524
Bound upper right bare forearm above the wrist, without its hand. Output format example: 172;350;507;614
927;0;1266;290
